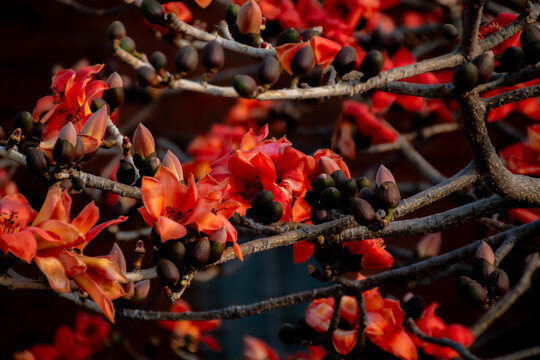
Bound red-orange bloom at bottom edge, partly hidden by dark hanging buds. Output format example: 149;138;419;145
306;289;418;360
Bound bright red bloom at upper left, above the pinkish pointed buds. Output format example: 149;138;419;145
32;64;107;140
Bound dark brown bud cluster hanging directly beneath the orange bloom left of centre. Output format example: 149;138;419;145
152;227;227;290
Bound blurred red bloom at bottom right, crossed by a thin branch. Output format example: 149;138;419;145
409;302;474;359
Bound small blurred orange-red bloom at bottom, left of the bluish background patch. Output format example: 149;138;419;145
159;299;221;352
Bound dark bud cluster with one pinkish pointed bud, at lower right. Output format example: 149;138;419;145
457;241;510;309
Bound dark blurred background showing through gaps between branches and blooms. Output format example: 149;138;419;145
0;0;539;359
